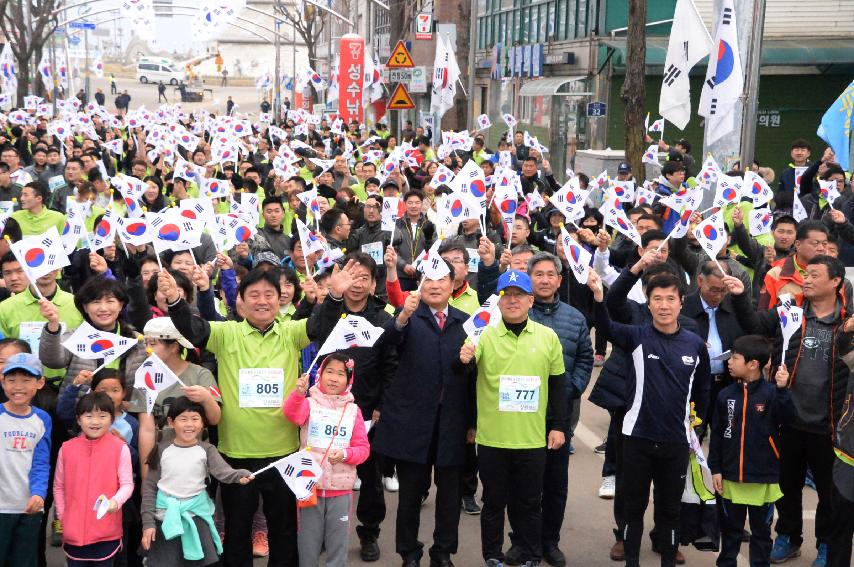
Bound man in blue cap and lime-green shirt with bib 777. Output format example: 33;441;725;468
460;270;567;567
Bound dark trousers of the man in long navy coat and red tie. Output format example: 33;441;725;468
396;461;461;561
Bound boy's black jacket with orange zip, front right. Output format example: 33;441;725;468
709;379;795;483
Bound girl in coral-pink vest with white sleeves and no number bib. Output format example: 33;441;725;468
53;392;133;567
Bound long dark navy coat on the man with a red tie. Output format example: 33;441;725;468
373;303;477;467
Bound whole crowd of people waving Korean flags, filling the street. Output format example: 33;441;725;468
0;97;854;567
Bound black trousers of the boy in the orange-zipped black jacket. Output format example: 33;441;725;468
716;498;774;567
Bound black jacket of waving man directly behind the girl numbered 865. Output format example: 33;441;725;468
313;295;397;419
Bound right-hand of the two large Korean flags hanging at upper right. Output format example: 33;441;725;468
698;0;744;145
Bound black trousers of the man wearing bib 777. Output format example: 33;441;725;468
477;445;546;562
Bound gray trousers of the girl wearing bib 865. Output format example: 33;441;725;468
297;494;353;567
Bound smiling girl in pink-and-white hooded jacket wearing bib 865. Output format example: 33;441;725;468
283;352;371;567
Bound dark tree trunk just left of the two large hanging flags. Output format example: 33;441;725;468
620;0;646;179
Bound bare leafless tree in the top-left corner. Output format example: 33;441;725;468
0;0;60;106
